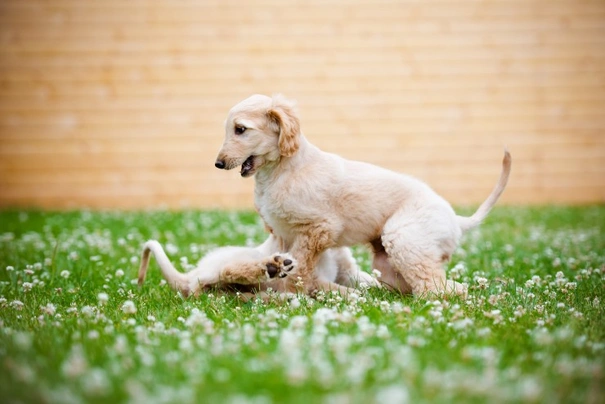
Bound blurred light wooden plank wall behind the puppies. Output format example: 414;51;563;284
0;0;605;209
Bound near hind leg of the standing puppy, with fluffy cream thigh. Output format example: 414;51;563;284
381;207;466;296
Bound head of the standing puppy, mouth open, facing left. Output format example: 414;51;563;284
214;95;300;177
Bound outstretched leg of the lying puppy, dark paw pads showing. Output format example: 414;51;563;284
219;254;296;285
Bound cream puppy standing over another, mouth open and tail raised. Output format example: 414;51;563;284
216;95;511;294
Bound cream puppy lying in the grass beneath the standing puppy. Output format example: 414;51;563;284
139;235;379;297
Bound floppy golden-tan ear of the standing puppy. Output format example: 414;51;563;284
267;94;300;157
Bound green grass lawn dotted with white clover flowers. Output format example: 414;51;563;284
0;206;605;403
